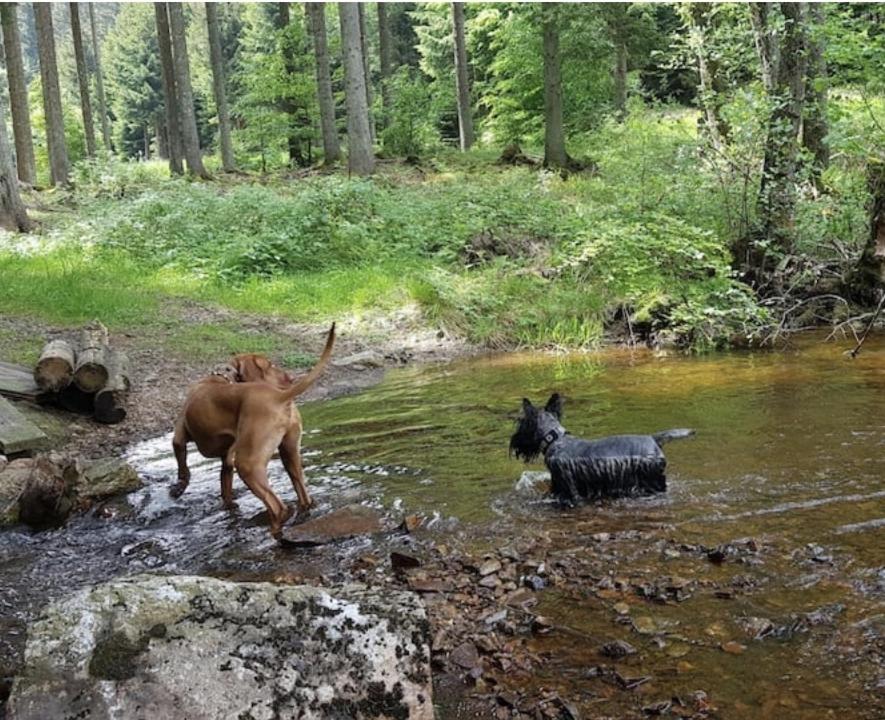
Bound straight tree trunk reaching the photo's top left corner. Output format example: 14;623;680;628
0;3;37;185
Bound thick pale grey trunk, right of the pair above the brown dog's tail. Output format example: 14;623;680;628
338;2;375;175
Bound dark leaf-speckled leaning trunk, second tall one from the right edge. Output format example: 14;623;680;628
758;2;806;256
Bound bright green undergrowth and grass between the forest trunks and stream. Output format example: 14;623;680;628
0;103;863;349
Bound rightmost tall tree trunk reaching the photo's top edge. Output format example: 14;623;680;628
802;3;830;190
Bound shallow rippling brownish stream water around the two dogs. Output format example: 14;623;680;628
0;338;885;720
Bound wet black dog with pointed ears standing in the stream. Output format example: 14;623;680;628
510;393;694;505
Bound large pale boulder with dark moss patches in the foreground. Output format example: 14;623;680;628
8;575;433;720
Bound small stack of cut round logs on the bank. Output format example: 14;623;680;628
34;323;129;424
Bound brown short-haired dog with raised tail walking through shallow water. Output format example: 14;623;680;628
170;323;335;538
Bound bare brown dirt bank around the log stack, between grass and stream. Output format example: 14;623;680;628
0;301;477;457
